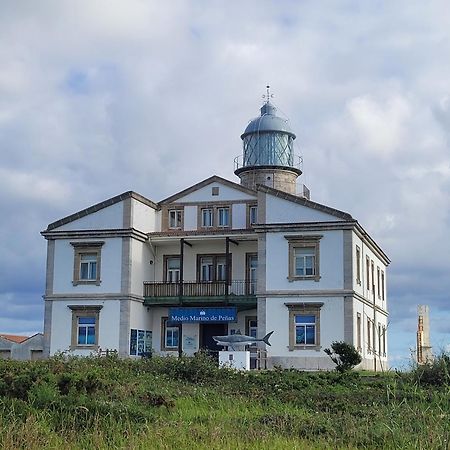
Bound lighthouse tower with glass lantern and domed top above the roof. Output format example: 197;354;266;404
234;86;302;195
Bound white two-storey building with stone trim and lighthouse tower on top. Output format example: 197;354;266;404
42;102;389;370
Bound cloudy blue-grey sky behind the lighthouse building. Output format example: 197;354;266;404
0;0;450;366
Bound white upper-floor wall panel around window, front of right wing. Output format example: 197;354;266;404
266;230;344;290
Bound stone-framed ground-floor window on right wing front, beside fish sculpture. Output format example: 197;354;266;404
286;303;323;351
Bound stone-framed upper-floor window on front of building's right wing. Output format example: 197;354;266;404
285;236;322;281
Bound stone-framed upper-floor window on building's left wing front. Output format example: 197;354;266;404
71;242;104;286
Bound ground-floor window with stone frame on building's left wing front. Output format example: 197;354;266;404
68;305;103;350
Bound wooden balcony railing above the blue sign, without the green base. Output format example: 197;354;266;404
144;280;256;298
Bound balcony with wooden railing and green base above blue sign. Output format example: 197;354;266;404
144;280;256;309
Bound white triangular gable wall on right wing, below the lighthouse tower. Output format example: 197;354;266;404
266;194;342;223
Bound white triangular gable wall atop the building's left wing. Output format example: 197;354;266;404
55;202;123;231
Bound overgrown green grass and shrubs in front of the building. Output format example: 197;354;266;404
0;355;450;450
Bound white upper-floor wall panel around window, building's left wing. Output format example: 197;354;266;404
53;238;122;294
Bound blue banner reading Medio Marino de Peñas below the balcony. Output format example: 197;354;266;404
168;307;237;325
